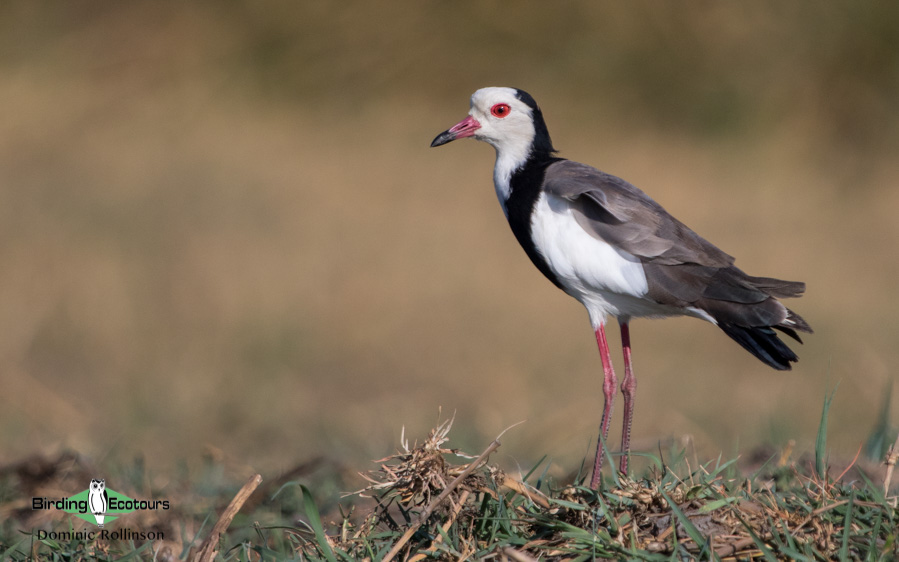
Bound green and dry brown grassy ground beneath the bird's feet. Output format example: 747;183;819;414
0;395;899;562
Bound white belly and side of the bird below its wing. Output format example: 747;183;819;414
531;193;684;326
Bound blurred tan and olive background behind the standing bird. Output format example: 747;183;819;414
0;1;899;470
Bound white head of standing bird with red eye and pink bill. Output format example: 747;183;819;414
431;88;555;160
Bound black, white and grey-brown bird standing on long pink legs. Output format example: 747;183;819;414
431;87;812;489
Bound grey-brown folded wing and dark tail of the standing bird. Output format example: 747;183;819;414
543;160;812;370
